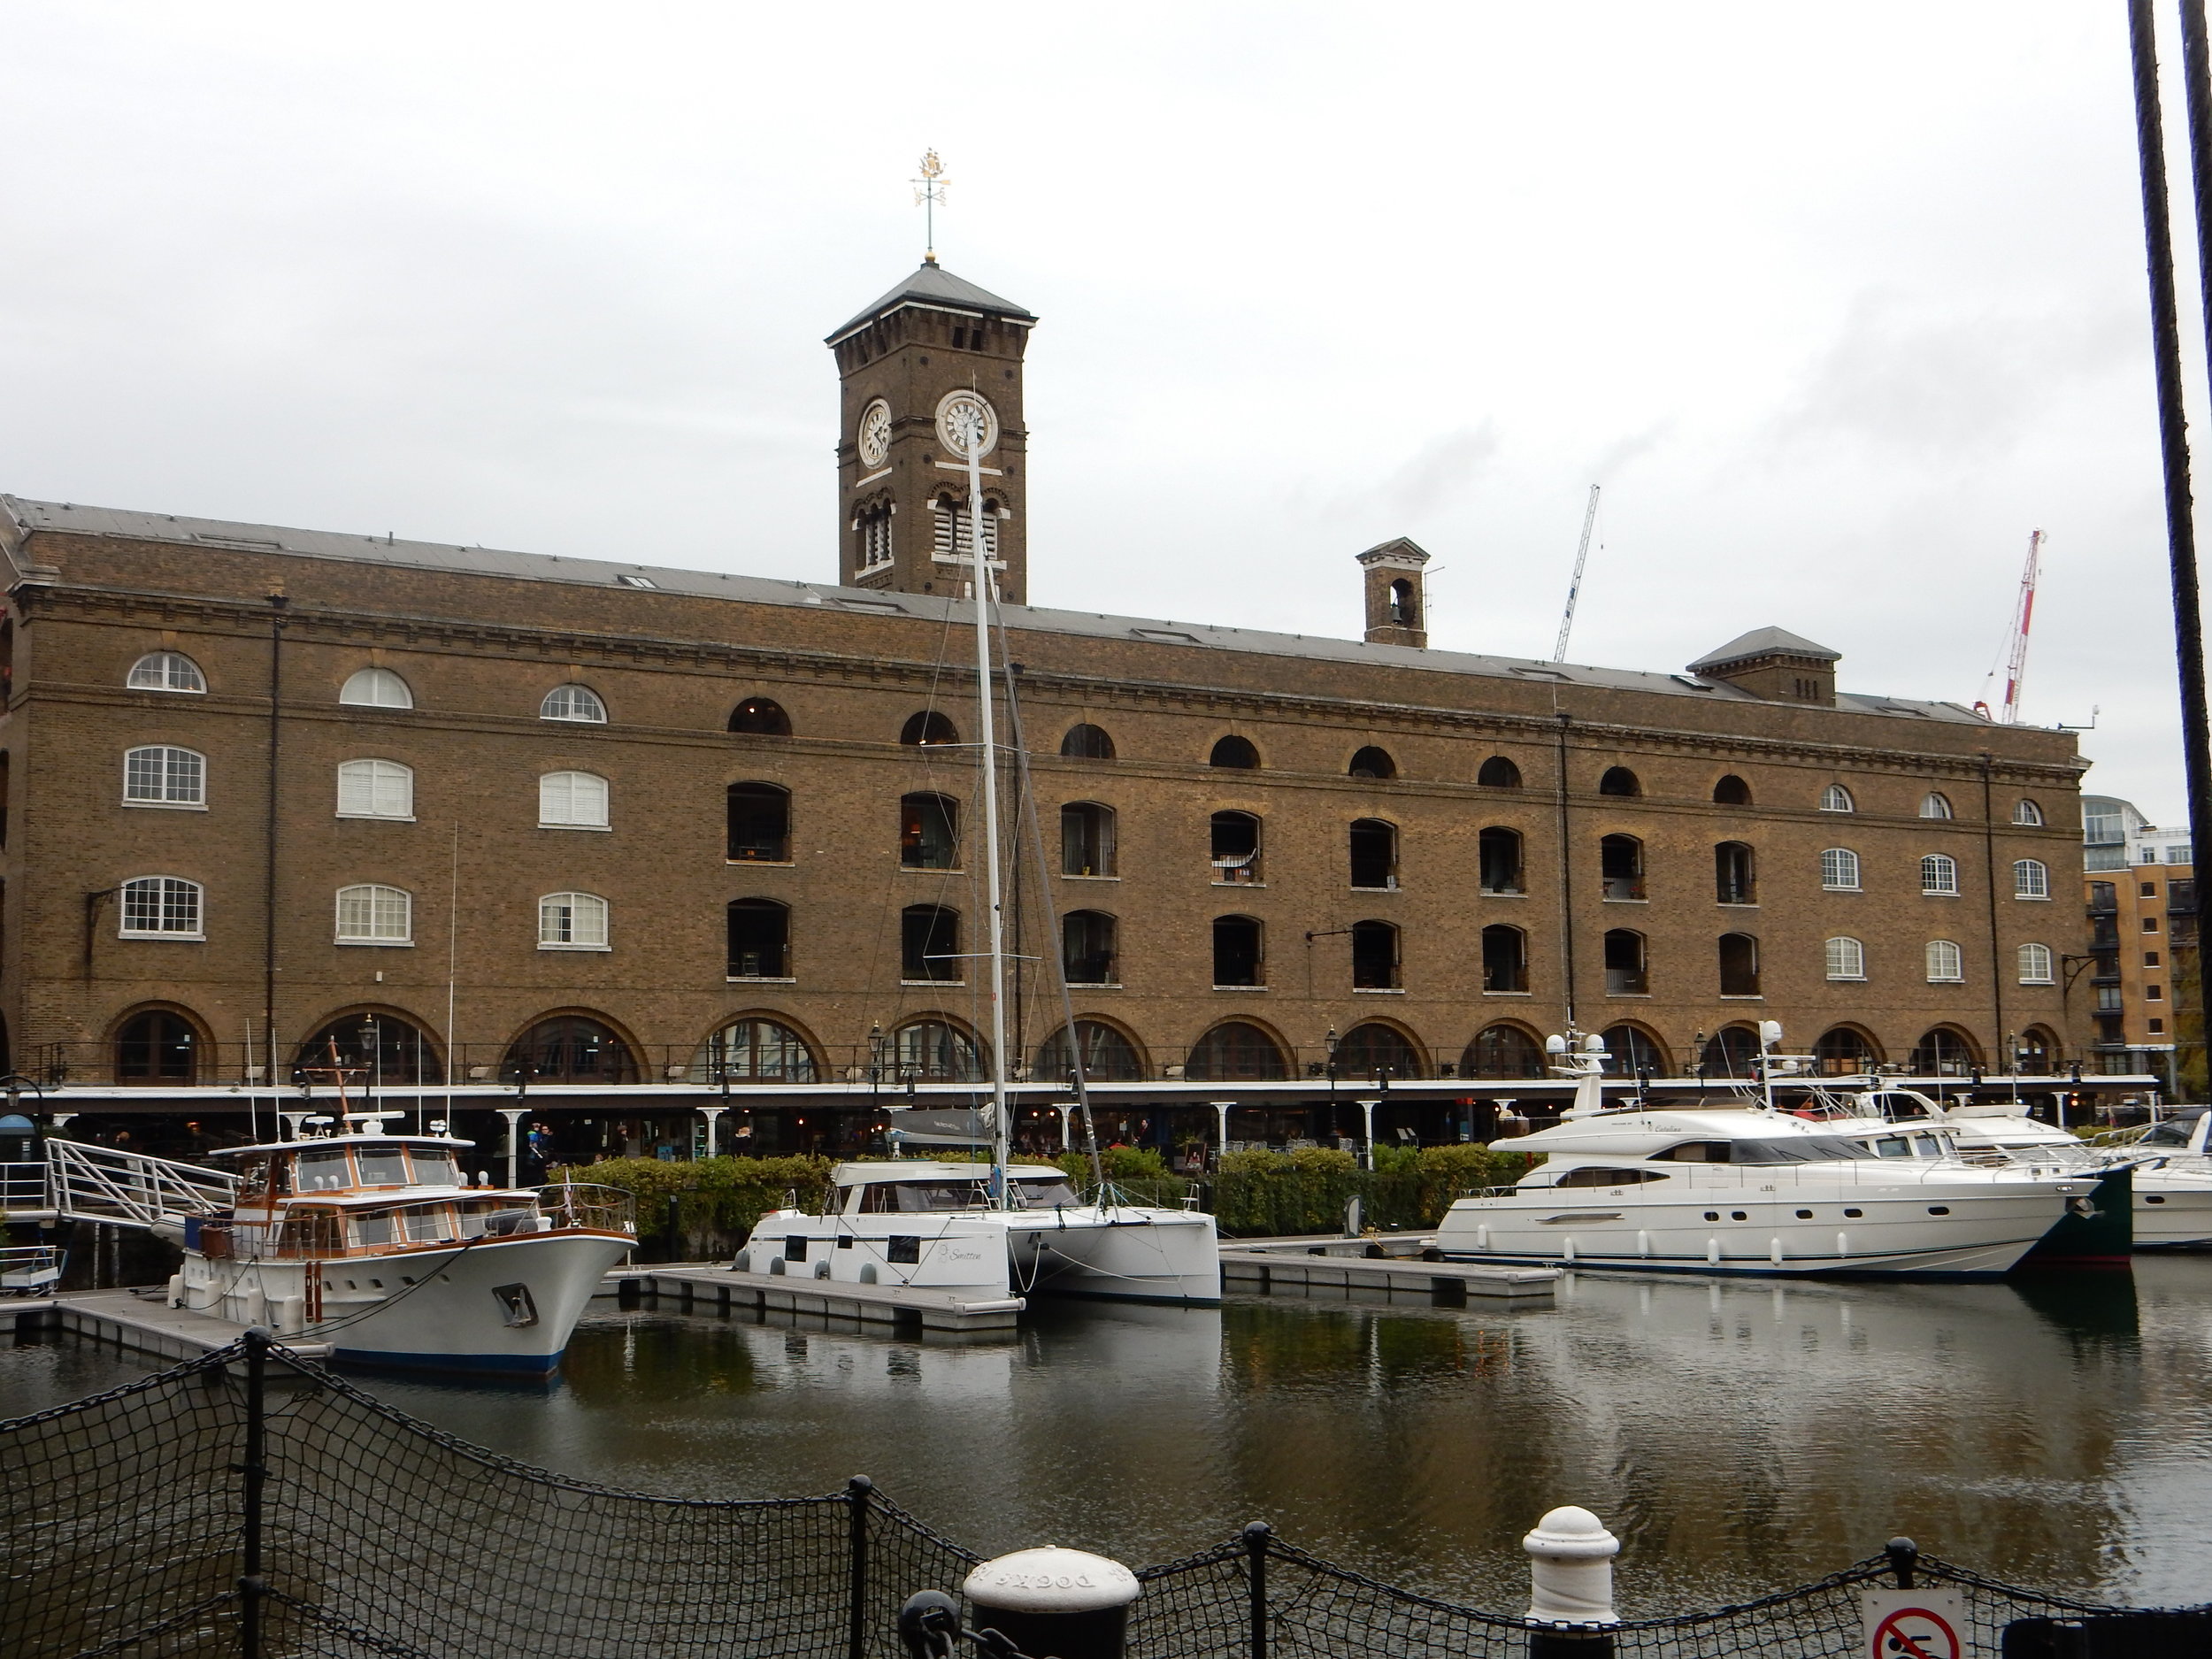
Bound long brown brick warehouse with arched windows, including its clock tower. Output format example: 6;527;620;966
0;265;2086;1155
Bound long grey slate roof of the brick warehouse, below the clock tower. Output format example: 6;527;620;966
0;495;1986;726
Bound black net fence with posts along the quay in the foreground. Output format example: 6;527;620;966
0;1336;2212;1659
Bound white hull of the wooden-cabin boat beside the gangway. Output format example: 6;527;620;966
180;1230;633;1376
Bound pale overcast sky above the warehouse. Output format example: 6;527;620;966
0;0;2212;823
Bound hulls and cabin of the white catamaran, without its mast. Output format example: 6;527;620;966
734;1159;1221;1308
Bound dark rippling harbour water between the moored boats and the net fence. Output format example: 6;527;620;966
0;1259;2212;1613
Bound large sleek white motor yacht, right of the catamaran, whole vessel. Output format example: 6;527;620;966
1433;1040;2095;1279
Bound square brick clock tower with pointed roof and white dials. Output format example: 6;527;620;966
827;257;1038;604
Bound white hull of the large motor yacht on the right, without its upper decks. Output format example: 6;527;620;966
1436;1179;2091;1279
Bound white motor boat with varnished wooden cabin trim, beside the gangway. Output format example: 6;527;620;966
155;1113;637;1376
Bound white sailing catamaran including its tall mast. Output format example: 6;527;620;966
734;387;1221;1305
